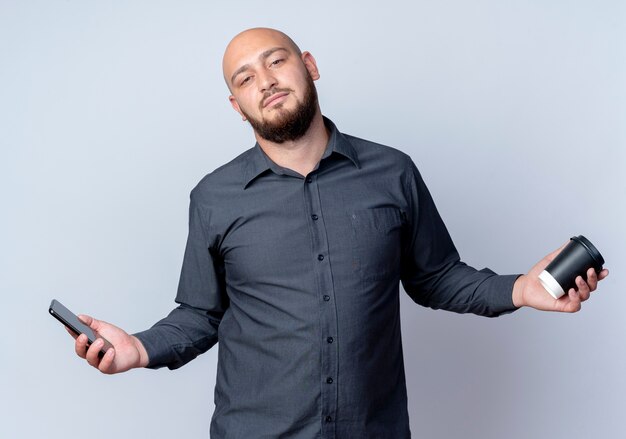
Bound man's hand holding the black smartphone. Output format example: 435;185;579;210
68;315;148;374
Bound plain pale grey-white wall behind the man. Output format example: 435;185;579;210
0;0;626;439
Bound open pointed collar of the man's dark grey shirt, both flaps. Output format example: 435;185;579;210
243;116;361;189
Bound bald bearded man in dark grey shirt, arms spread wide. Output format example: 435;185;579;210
70;29;608;439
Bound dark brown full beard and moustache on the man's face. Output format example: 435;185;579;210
241;75;317;143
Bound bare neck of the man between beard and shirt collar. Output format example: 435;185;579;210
256;110;330;176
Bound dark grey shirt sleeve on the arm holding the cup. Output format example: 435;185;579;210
401;159;520;317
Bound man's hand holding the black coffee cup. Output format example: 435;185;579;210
513;243;609;312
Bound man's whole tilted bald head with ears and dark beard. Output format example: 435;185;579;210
224;29;319;143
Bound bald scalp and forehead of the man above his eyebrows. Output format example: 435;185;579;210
222;27;302;91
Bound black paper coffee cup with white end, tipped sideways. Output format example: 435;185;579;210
539;235;604;299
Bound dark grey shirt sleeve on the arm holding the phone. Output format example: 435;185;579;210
134;191;229;369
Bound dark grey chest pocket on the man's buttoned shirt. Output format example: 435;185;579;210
349;207;402;280
